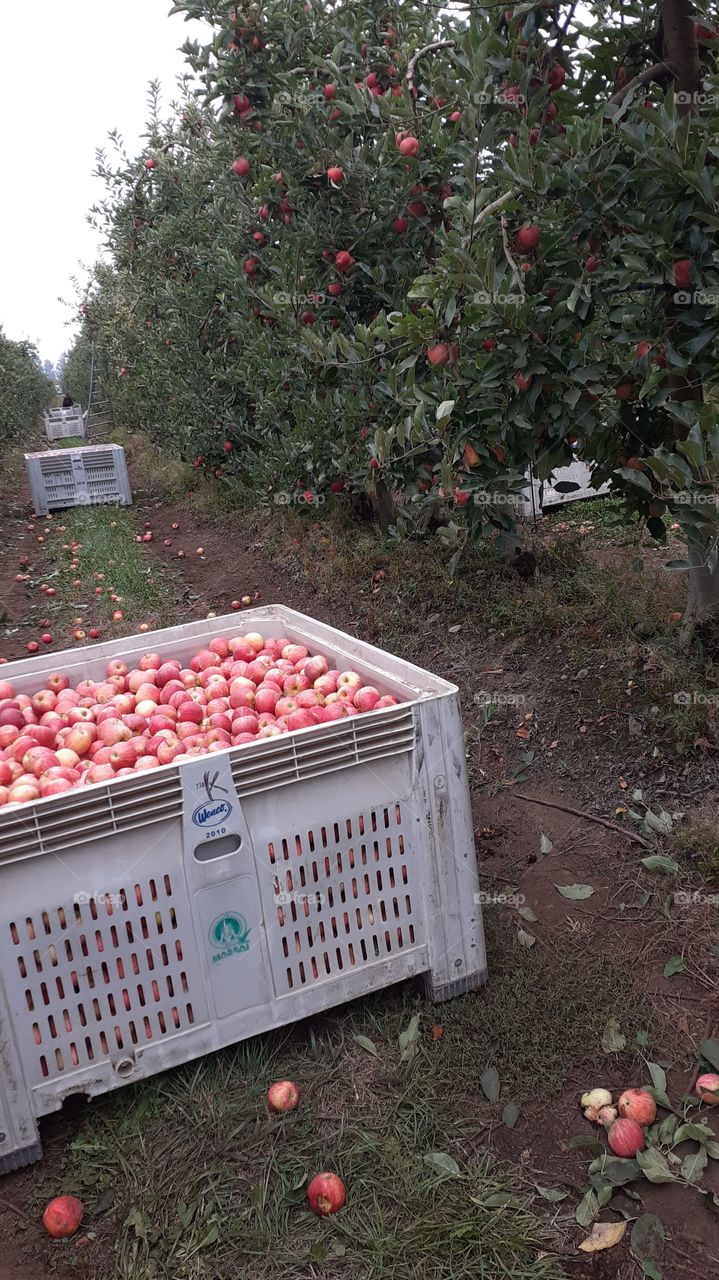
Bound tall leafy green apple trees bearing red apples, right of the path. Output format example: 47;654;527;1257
64;0;719;617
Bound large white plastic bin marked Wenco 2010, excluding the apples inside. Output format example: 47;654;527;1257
0;605;486;1171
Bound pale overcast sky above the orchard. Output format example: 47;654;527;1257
0;0;207;364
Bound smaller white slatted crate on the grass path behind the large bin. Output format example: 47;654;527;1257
26;444;132;516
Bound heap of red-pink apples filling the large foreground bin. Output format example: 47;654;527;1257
0;632;399;808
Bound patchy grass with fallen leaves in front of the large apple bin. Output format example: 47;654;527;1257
29;925;649;1280
